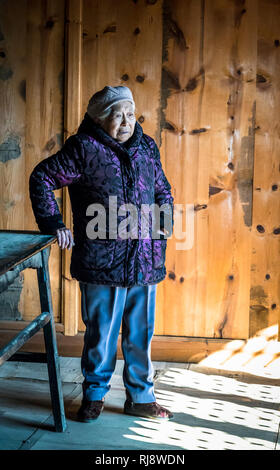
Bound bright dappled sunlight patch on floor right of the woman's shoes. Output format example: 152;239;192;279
124;368;280;450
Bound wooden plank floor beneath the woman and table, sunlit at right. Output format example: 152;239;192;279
0;357;280;452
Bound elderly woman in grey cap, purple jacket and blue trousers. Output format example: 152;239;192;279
29;86;173;422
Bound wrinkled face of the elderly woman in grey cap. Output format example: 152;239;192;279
101;101;136;142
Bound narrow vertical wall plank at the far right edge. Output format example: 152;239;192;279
250;0;280;338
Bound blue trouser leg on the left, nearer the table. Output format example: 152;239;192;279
80;283;127;400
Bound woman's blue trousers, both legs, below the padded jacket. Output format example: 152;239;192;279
80;282;156;403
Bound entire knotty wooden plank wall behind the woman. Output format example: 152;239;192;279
0;0;280;344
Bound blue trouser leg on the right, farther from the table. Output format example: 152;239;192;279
122;284;157;403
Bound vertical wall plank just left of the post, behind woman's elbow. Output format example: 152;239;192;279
22;0;64;321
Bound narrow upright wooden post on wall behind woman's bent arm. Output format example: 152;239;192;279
61;0;82;336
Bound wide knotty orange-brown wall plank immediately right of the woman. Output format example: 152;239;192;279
162;0;257;338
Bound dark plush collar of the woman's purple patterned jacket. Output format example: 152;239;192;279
77;113;143;156
